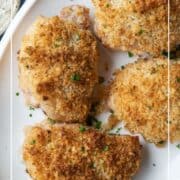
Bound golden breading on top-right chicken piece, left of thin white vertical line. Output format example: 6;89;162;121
92;0;168;56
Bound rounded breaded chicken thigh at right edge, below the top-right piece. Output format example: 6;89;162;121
109;58;180;144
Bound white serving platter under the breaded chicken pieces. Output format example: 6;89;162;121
0;0;180;180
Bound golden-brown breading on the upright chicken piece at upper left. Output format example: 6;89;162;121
18;13;99;122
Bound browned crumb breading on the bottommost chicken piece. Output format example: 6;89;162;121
23;121;141;180
